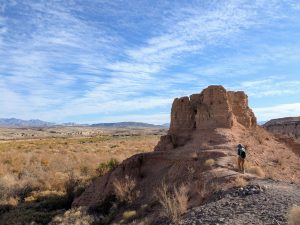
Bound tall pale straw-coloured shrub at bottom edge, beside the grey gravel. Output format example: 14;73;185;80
157;183;189;223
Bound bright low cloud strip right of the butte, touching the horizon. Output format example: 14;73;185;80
253;103;300;121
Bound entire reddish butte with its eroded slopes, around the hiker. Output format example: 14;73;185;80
73;86;300;211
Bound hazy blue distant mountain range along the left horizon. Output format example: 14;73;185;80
0;118;170;128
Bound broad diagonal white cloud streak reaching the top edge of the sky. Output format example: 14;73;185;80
118;1;260;74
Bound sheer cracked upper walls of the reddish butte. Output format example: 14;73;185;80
156;85;257;150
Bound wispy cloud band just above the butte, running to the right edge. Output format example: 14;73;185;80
190;43;300;78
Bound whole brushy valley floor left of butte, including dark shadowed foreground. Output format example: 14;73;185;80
0;131;159;224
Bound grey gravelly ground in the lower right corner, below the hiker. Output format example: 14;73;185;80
176;180;300;225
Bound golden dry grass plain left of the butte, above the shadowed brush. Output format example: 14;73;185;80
0;135;159;194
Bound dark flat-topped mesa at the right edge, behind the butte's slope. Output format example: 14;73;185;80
263;117;300;141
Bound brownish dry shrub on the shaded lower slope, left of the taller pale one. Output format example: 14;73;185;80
113;176;139;203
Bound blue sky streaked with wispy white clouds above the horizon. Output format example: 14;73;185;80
0;0;300;124
